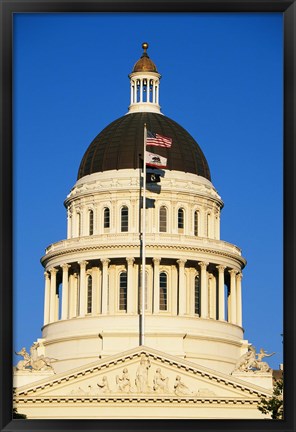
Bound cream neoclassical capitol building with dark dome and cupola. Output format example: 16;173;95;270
14;43;272;419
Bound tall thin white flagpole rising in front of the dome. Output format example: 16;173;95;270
140;123;147;345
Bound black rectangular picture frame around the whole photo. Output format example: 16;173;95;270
0;0;296;432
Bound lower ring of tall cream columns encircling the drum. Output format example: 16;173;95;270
44;257;242;326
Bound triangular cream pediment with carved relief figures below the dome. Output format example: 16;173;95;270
16;346;270;401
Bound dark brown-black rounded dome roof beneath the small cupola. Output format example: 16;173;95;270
77;112;211;180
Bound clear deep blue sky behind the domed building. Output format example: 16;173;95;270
13;13;283;368
